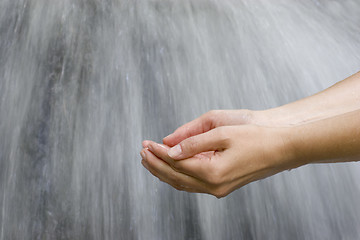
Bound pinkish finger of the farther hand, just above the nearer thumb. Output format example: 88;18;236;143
163;111;215;147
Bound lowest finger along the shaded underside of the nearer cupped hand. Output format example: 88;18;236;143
143;150;205;192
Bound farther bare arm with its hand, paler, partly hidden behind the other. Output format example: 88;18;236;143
163;72;360;147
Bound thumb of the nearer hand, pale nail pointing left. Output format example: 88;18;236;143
168;127;229;160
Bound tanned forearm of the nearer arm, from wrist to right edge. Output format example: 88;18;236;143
285;110;360;167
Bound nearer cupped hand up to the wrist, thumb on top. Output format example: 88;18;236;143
141;125;292;198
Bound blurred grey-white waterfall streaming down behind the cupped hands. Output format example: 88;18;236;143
0;0;360;240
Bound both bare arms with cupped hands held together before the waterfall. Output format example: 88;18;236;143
140;73;360;198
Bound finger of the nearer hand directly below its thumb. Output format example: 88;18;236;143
148;142;215;182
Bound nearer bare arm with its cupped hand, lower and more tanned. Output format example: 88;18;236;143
141;110;360;198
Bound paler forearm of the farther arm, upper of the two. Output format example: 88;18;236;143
257;72;360;125
